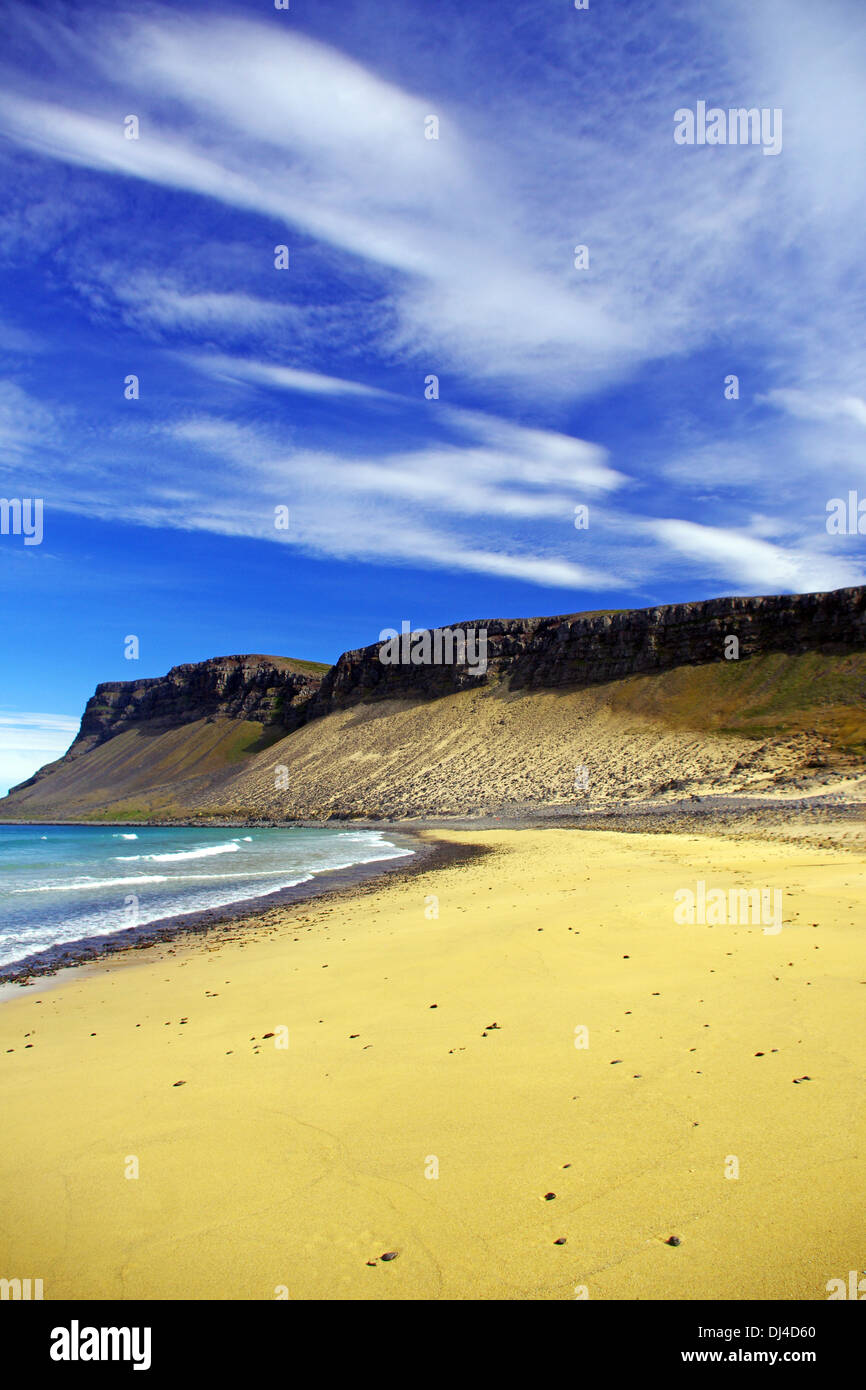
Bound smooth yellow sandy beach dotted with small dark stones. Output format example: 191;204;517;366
0;828;866;1300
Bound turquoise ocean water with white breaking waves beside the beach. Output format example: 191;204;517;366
0;826;413;967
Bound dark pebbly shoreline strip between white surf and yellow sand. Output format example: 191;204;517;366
0;821;484;1004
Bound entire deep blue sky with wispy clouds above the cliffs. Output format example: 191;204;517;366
0;0;866;790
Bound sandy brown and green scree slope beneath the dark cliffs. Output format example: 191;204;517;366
0;648;866;820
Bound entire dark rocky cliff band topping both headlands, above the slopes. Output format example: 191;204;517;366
4;588;866;809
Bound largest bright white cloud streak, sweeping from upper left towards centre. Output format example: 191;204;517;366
0;11;742;398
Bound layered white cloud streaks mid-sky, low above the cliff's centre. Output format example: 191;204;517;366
162;394;626;588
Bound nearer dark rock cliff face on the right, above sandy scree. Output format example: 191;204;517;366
289;588;866;727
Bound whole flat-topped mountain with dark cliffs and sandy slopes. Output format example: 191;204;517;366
0;588;866;821
